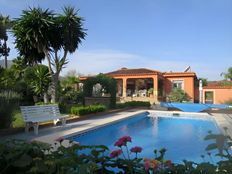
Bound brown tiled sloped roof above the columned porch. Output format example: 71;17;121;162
105;68;160;76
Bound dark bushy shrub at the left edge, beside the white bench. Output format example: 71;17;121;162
0;91;20;128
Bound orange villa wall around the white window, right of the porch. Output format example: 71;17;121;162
164;77;195;101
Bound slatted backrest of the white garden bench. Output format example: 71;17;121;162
20;105;60;122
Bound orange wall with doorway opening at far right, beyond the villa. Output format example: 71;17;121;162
203;89;232;104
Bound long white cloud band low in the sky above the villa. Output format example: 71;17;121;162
62;50;226;80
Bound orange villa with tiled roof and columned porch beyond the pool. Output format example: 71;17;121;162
80;67;199;103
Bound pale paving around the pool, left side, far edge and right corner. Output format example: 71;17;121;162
0;109;232;144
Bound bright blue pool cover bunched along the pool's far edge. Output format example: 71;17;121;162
160;102;229;112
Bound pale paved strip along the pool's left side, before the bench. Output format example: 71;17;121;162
0;109;146;144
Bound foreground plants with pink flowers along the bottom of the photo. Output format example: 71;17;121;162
0;132;232;174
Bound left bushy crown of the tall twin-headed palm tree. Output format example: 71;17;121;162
13;8;54;65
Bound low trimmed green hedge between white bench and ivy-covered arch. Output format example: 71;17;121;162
71;105;106;115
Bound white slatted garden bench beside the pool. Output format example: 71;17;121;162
20;105;68;135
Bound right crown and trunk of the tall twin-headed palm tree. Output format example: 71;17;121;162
51;7;86;102
